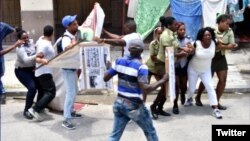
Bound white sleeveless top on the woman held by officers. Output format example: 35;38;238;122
189;40;215;72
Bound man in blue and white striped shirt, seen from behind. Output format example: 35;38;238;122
104;39;168;141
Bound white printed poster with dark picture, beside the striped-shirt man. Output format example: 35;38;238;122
81;45;112;89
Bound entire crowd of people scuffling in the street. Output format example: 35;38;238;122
0;14;237;141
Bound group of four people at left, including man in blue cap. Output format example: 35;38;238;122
0;15;82;129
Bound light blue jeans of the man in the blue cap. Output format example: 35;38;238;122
62;69;77;120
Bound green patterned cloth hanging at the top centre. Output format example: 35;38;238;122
135;0;170;39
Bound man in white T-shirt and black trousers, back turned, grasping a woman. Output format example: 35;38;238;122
28;25;56;121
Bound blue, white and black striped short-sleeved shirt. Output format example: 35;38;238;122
108;56;148;100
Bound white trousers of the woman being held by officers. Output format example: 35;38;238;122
187;65;218;106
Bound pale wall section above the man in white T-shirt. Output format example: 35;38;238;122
20;0;54;41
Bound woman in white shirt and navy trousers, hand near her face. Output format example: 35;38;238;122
15;30;41;119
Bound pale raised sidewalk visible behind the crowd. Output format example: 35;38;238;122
2;45;250;95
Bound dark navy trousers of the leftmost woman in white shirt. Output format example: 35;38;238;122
15;68;42;111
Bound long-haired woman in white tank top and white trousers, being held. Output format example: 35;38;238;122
184;27;222;119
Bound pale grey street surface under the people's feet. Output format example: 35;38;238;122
1;93;250;141
